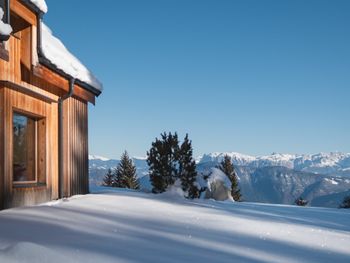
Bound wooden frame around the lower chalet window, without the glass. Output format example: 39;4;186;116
11;108;47;187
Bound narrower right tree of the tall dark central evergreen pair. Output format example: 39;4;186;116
178;134;200;199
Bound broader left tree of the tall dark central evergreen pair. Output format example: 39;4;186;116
147;133;179;193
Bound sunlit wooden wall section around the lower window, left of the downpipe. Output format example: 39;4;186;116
0;86;58;208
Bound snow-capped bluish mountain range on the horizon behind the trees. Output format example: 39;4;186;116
89;152;350;207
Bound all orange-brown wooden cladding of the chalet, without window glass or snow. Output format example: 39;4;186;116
0;0;95;209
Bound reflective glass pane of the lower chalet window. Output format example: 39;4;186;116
13;113;36;182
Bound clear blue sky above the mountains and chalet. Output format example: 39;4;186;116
45;0;350;157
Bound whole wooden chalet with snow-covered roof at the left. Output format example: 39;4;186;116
0;0;102;209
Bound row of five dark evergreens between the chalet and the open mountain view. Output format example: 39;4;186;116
104;132;242;201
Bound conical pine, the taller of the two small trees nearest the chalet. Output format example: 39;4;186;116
114;151;140;189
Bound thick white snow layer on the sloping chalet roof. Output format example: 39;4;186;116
42;23;102;91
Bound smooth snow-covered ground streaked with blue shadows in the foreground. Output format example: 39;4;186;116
0;188;350;263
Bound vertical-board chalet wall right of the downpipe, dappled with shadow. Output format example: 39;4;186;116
63;97;89;199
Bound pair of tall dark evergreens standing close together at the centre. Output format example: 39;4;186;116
147;133;199;198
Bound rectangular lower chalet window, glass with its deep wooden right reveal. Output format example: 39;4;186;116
12;112;45;183
